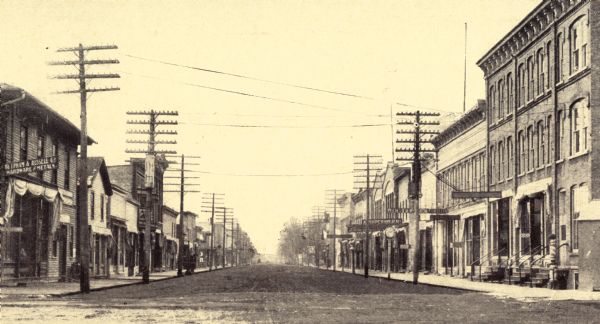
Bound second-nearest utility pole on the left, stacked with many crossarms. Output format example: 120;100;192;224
125;110;179;284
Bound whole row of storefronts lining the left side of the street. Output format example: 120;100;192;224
0;84;211;281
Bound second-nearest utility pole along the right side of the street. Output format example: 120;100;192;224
354;154;383;278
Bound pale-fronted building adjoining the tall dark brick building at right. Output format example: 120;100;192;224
433;100;490;276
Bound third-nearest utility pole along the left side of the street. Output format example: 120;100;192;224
163;154;200;277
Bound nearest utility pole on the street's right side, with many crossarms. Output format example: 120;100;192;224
396;110;440;284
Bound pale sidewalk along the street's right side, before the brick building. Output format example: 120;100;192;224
321;268;600;300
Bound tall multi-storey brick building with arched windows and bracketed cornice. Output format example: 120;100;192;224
478;0;600;290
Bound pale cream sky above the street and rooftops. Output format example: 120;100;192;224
0;0;540;253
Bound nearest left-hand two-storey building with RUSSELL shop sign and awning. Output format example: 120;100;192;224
0;84;83;279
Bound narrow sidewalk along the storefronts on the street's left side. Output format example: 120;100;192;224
0;267;220;300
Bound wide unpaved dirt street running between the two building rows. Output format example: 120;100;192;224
0;264;600;323
